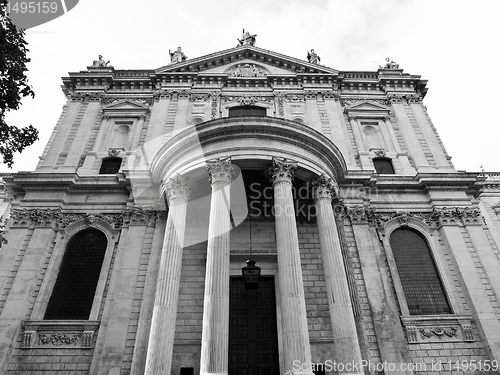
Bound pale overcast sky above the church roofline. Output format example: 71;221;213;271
0;0;500;172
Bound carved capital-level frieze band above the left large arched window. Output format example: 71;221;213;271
10;207;165;229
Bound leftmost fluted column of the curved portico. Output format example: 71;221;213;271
144;175;189;375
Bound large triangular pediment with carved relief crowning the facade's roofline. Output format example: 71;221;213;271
156;45;338;76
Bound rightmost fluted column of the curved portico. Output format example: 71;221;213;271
313;175;363;374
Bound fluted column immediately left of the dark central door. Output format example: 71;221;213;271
200;158;234;374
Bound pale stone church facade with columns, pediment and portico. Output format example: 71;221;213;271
0;44;500;375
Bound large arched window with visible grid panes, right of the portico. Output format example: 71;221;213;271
390;228;451;315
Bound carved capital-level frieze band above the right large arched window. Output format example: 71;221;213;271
335;204;483;228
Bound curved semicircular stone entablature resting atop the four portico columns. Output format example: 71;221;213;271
152;117;346;181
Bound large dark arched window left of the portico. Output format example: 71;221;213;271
44;229;108;320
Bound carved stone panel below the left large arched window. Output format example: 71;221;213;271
21;320;100;349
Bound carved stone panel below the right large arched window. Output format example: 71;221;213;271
401;315;474;344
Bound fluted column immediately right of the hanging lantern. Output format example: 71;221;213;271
270;158;312;374
